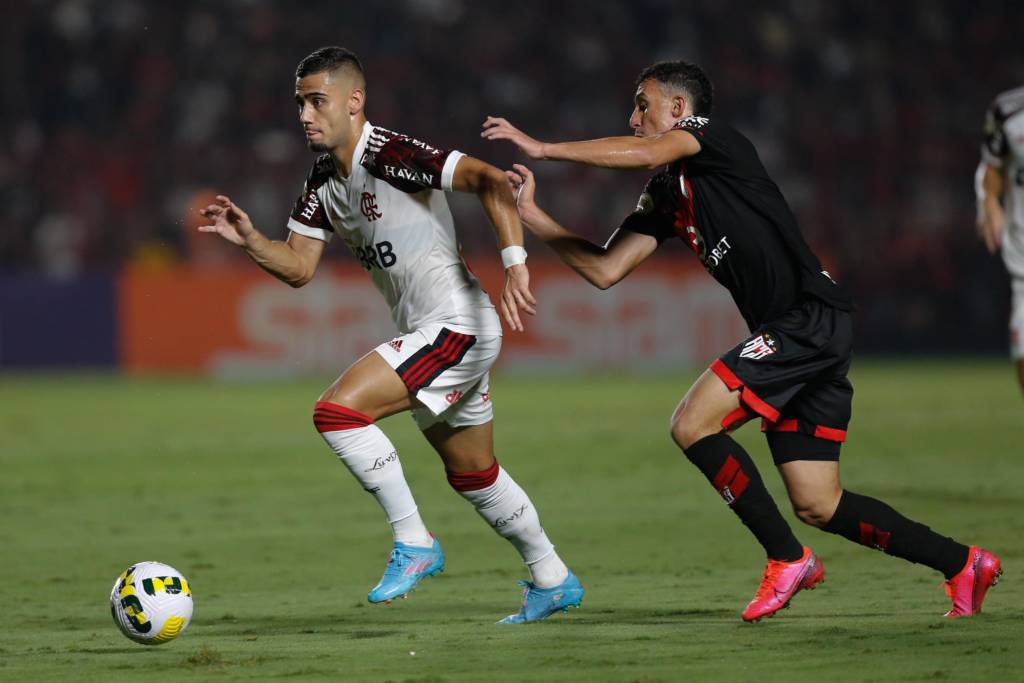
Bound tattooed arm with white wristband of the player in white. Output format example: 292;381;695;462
452;157;537;332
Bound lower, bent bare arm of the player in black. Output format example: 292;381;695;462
506;164;657;290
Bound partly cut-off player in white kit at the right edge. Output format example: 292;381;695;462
975;87;1024;389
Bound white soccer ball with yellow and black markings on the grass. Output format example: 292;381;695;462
111;562;193;645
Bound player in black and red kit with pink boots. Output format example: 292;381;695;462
481;61;1001;621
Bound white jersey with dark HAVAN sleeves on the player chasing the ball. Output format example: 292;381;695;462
288;122;501;335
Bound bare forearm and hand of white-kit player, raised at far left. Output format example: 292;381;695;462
199;195;325;287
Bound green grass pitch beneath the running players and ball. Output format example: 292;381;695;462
0;360;1024;683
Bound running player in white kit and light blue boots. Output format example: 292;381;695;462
199;47;584;624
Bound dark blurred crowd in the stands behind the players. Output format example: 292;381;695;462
0;0;1024;353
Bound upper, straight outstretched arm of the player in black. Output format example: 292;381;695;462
480;117;700;168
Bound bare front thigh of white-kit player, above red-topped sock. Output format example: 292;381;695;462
321;351;417;420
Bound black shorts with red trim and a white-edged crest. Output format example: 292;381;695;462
711;298;853;465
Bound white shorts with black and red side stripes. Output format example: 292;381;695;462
374;325;502;430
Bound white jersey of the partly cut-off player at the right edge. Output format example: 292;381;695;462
981;87;1024;278
